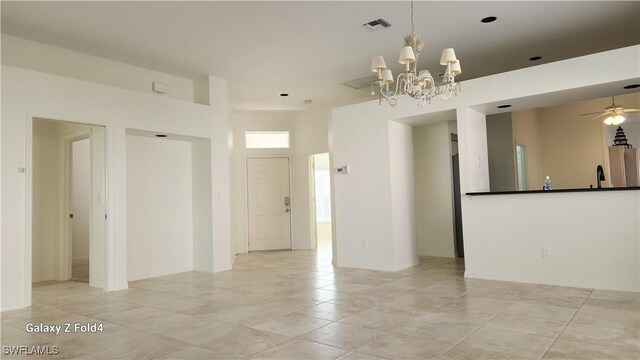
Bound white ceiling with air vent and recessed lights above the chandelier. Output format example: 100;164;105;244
2;1;640;110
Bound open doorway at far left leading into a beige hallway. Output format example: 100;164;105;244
27;118;106;288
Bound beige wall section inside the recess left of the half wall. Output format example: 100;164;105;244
413;121;455;257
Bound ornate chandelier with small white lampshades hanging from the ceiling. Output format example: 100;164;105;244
371;1;462;107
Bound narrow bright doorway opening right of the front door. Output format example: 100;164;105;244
309;153;332;257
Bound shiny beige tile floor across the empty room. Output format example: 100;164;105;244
1;245;640;359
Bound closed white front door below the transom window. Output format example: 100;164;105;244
247;158;291;251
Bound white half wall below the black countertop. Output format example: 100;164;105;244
464;190;640;291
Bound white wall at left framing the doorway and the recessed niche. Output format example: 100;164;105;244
1;63;232;310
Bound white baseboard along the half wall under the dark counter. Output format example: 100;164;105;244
464;271;640;292
